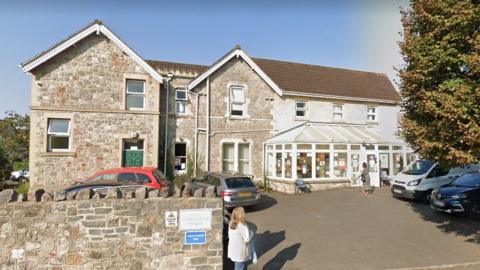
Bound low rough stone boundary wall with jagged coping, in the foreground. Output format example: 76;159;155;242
0;188;223;270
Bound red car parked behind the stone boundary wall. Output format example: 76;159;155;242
64;167;168;194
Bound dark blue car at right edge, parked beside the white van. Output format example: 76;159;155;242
430;173;480;220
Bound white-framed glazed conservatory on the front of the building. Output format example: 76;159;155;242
265;122;416;193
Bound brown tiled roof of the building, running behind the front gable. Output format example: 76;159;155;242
147;52;400;103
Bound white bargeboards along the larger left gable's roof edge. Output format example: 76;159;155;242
20;20;163;82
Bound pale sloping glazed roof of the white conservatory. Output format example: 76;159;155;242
267;122;384;144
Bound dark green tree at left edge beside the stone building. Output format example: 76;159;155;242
0;112;30;176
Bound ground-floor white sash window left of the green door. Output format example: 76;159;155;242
47;119;70;152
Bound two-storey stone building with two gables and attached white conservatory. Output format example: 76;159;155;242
22;21;414;192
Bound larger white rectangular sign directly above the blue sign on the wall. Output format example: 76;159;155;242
179;208;212;231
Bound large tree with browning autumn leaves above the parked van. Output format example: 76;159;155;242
399;0;480;166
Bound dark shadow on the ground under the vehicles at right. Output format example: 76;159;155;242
404;200;480;244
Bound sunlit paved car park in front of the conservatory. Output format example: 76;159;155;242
225;188;480;270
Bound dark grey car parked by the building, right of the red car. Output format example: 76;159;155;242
191;172;260;208
